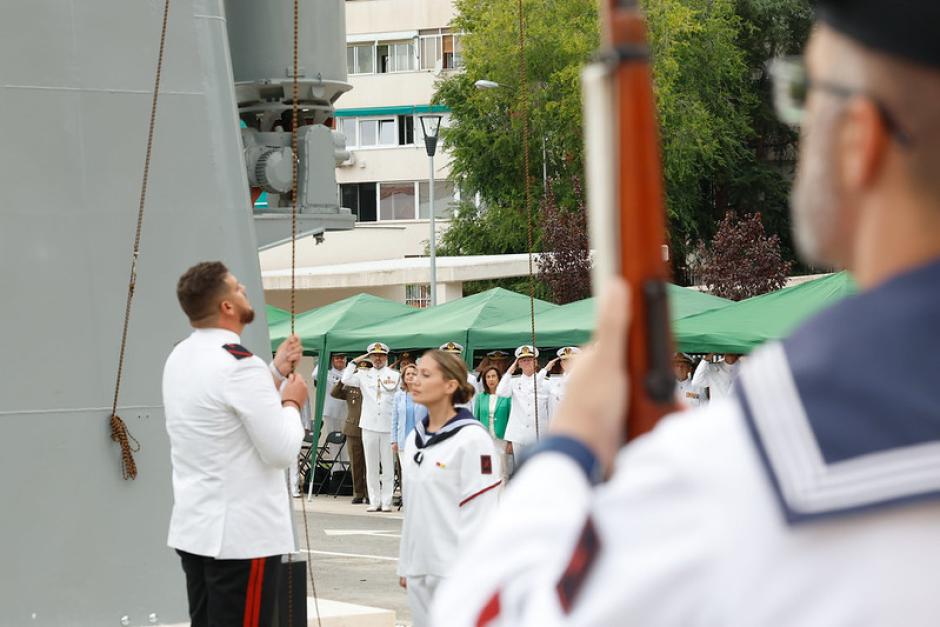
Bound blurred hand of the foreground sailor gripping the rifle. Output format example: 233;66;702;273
551;279;630;472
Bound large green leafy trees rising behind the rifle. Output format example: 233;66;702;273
436;0;812;280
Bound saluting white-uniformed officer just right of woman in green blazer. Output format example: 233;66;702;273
496;346;548;462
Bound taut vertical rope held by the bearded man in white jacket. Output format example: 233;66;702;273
287;0;323;627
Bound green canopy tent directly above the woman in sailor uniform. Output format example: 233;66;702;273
327;287;556;363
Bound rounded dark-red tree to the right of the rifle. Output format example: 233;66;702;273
693;211;791;300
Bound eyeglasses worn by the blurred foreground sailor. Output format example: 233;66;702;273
770;57;911;146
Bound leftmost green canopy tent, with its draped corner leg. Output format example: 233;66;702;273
270;294;419;441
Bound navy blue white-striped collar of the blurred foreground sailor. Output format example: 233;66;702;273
737;261;940;524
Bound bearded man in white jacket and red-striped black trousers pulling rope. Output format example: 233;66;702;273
163;262;307;627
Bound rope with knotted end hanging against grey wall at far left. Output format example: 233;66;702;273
110;0;170;480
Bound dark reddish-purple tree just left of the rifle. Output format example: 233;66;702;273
538;178;591;305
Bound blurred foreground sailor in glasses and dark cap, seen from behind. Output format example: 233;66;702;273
432;0;940;627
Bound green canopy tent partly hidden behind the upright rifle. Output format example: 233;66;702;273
468;284;732;352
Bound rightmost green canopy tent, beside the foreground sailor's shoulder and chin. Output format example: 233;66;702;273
674;272;857;354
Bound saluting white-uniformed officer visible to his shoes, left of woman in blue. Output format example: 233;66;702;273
342;342;401;512
